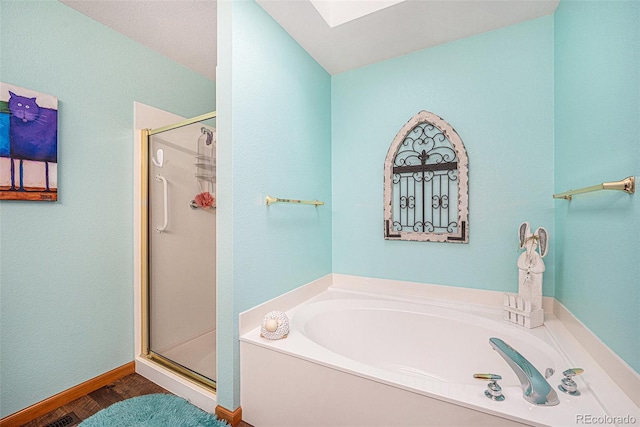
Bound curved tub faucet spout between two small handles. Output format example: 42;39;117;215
489;338;560;406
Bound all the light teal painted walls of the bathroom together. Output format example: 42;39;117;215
0;1;640;426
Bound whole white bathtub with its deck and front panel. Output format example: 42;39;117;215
241;278;638;427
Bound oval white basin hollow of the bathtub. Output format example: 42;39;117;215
292;296;566;386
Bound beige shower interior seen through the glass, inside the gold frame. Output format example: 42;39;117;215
148;123;216;380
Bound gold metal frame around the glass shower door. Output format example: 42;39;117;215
140;111;217;393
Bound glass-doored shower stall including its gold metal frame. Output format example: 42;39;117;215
141;112;216;391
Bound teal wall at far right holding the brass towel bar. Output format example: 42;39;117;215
555;1;640;372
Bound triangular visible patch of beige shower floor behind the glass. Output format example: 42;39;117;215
160;329;216;381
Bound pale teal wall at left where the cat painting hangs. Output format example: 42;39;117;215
0;1;215;417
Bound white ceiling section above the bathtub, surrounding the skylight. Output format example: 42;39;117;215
257;0;559;74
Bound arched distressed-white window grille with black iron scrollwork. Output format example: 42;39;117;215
384;111;469;243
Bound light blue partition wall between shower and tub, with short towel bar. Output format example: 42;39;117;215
217;1;331;409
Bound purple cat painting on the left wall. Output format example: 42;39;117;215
0;82;58;201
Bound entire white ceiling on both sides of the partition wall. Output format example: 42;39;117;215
61;0;559;80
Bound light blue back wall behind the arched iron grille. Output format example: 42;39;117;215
331;16;555;295
